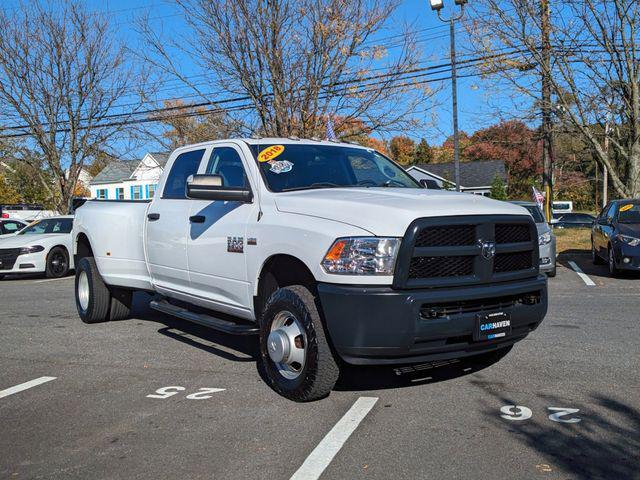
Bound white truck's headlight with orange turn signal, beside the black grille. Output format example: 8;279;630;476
322;237;401;275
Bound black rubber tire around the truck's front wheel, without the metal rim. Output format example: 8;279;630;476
260;285;340;402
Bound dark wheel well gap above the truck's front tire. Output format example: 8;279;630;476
253;254;316;317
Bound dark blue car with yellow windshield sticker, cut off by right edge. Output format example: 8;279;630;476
591;200;640;275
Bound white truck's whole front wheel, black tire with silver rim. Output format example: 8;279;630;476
260;285;340;402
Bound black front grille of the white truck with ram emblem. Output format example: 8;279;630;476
393;215;539;289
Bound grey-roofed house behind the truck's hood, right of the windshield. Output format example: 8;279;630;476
407;160;507;196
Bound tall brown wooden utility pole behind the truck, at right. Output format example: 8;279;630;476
540;0;553;222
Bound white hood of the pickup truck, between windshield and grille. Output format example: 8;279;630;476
275;188;529;237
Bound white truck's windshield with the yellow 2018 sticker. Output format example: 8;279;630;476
246;144;420;192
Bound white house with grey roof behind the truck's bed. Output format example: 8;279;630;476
89;152;169;200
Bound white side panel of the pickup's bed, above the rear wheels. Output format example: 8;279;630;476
73;200;152;290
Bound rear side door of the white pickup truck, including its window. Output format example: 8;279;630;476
146;148;206;295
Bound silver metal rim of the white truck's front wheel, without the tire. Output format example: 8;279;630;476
267;311;307;380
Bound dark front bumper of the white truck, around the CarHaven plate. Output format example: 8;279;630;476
318;275;547;365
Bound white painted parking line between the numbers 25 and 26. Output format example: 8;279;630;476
291;397;378;480
